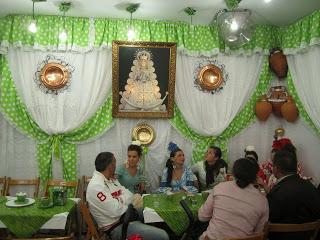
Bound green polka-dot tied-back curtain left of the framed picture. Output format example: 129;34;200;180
0;57;113;186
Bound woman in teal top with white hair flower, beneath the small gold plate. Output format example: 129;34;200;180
116;144;145;193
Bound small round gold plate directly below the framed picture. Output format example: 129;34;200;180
132;123;155;145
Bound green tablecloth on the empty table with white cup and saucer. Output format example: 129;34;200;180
0;197;76;237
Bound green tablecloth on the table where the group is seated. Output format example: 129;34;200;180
143;193;207;235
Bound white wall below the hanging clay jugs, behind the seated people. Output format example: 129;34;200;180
229;115;320;183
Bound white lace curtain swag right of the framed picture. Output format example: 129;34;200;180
175;54;263;136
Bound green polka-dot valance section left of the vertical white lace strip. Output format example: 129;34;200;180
0;15;93;52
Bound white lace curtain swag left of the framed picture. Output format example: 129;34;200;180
8;49;112;134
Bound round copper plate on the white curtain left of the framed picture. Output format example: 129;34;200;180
40;63;70;89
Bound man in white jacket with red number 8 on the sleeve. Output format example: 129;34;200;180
86;152;169;240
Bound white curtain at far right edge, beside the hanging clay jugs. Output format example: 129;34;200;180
287;45;320;128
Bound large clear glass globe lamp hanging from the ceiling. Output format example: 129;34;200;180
216;9;255;47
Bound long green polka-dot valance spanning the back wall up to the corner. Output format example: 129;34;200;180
0;15;277;56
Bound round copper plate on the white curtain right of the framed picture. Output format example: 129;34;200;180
197;64;223;91
